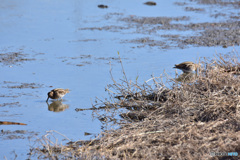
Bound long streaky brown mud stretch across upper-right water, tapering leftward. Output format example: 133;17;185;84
82;16;240;49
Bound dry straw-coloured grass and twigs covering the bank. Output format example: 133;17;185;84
32;51;240;159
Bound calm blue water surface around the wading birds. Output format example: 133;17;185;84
0;0;239;159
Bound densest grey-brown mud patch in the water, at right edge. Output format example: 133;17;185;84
174;21;240;48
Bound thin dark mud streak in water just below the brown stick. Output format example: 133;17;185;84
0;130;38;140
